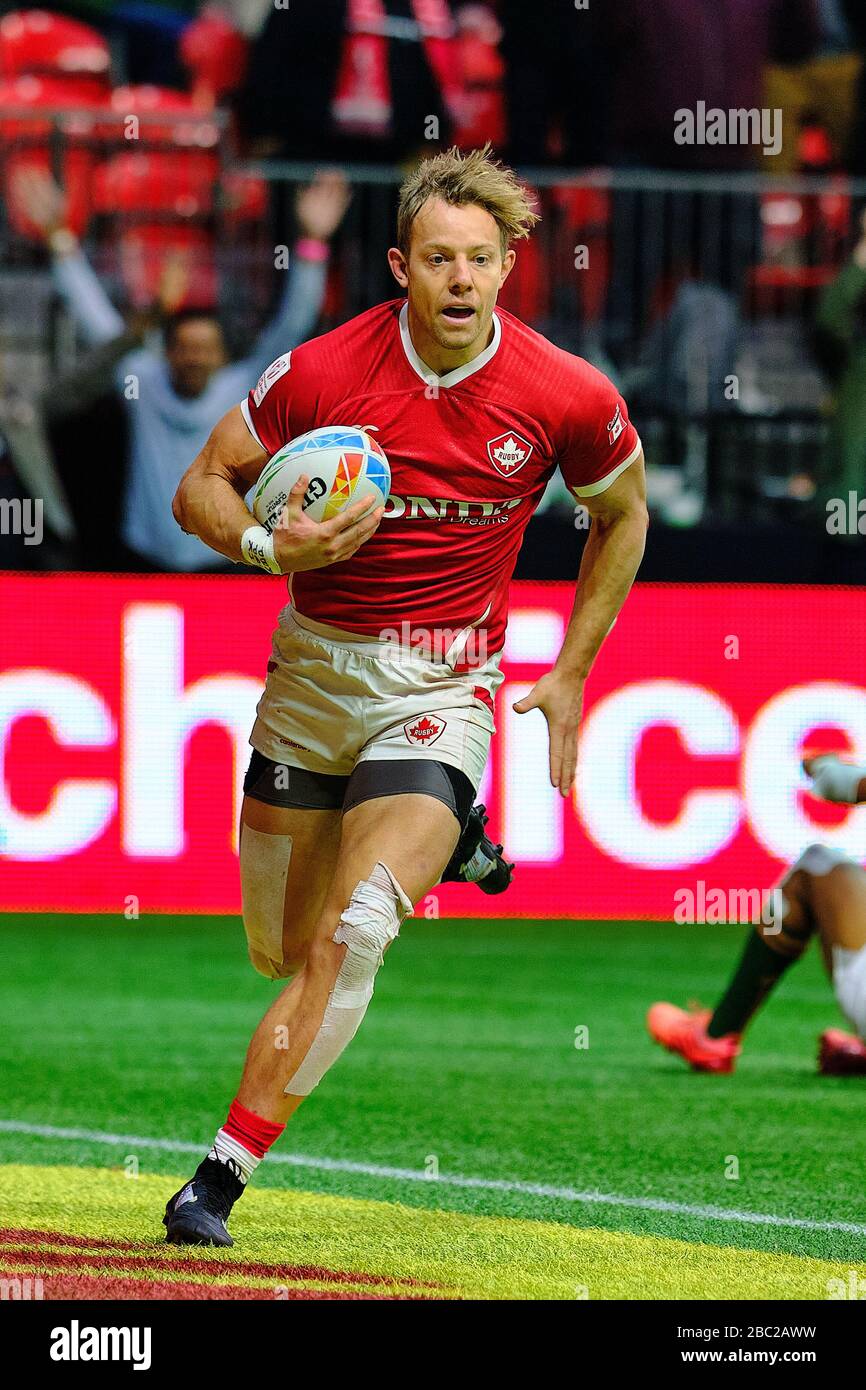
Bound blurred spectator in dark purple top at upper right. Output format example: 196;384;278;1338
602;0;817;170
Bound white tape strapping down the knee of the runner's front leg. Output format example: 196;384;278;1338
285;863;413;1095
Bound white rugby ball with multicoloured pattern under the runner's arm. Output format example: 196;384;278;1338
252;425;391;531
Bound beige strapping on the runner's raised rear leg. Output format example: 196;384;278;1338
239;826;292;980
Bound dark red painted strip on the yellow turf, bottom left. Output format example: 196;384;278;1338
0;1232;442;1289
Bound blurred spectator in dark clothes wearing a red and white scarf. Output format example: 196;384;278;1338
238;0;459;161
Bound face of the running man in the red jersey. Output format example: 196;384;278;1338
389;197;514;360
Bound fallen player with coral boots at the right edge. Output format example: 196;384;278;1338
646;753;866;1076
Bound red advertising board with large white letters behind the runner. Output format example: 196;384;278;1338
0;574;866;919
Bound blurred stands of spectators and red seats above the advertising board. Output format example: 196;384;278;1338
0;0;866;580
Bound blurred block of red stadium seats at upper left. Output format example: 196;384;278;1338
0;11;254;304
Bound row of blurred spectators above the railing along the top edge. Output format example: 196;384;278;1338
23;0;866;172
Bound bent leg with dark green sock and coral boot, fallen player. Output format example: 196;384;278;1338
646;845;833;1072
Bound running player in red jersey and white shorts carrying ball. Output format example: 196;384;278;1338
164;149;646;1245
